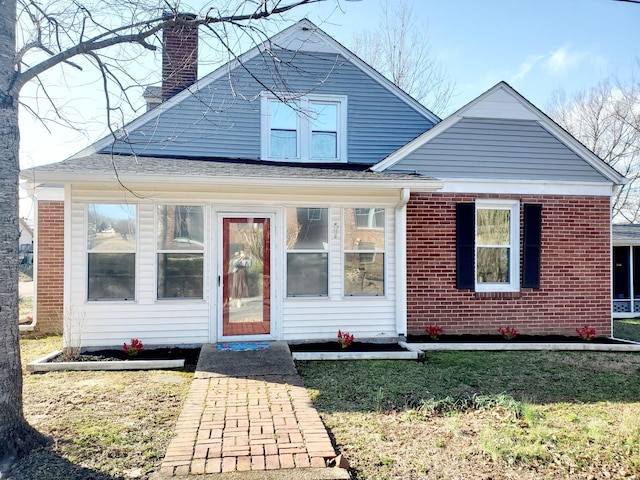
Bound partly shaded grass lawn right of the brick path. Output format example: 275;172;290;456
297;352;640;480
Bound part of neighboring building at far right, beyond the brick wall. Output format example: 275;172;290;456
612;224;640;318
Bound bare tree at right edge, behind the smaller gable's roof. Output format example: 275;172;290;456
547;79;640;223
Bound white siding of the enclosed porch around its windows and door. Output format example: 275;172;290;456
65;187;398;347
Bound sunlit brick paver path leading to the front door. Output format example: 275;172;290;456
160;375;336;476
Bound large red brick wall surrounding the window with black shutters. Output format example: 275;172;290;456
407;194;611;336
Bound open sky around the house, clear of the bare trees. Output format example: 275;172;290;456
20;0;640;216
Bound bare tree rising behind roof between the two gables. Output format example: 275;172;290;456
352;0;455;116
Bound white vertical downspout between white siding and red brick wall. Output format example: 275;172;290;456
395;188;411;340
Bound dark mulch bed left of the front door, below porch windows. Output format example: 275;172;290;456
50;347;200;371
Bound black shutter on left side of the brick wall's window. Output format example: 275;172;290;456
456;203;476;288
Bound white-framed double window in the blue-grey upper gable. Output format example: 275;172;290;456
261;94;347;163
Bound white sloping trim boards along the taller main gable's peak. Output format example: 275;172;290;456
69;19;440;158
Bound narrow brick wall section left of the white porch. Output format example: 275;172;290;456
36;201;64;333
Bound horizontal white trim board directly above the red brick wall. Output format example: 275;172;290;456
440;178;614;197
